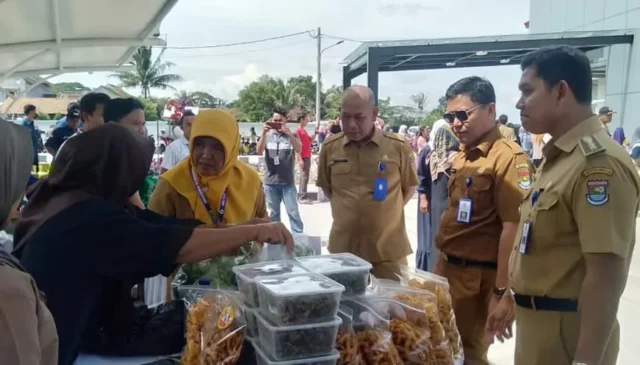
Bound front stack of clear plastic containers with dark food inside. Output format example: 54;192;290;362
254;273;345;365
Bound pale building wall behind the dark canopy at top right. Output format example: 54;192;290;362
529;0;640;137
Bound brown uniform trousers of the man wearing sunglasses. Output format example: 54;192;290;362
435;255;497;365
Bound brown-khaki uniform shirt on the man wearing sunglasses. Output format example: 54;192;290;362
435;127;533;263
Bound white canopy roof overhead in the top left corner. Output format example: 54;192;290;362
0;0;178;82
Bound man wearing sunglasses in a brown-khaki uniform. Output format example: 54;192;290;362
434;76;532;365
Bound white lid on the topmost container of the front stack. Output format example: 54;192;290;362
257;273;345;297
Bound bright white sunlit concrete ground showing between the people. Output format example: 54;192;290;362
281;186;640;365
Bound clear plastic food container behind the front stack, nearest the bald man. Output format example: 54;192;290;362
298;253;372;296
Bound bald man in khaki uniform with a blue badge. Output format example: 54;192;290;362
316;86;418;280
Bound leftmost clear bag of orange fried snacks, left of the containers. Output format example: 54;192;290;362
178;286;246;365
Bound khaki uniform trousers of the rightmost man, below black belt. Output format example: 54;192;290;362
515;305;620;365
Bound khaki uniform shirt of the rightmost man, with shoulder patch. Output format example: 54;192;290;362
510;117;640;299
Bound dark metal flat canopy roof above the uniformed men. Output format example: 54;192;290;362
343;30;633;80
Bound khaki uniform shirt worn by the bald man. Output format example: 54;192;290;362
316;128;418;263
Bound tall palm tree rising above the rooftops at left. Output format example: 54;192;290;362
111;47;183;98
